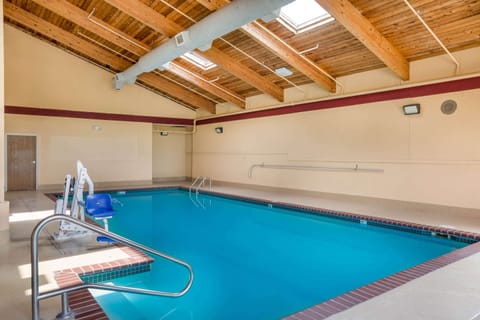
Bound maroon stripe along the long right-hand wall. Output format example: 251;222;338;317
197;77;480;125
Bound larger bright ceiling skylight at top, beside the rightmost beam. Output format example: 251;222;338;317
278;0;335;33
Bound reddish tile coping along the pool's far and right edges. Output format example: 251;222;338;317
50;186;480;320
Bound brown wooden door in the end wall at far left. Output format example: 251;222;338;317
7;135;37;191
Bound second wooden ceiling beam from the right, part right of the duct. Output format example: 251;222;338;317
242;21;336;92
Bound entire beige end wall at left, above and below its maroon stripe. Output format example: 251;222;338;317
1;25;195;189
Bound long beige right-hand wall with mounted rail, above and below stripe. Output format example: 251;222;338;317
192;49;480;208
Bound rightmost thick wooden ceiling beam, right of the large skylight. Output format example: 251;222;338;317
316;0;410;80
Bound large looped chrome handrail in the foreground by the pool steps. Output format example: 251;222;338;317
30;215;193;320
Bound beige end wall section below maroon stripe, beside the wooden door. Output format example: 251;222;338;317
5;114;152;187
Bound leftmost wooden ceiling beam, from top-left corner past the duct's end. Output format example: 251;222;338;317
3;2;215;112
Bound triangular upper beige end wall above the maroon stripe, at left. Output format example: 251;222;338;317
5;25;195;118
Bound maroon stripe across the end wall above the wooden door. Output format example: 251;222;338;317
5;106;193;126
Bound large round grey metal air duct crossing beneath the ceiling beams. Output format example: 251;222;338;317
113;0;293;90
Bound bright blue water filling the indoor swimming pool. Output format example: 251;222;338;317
89;189;467;320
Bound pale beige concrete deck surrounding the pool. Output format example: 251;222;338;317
0;182;480;320
